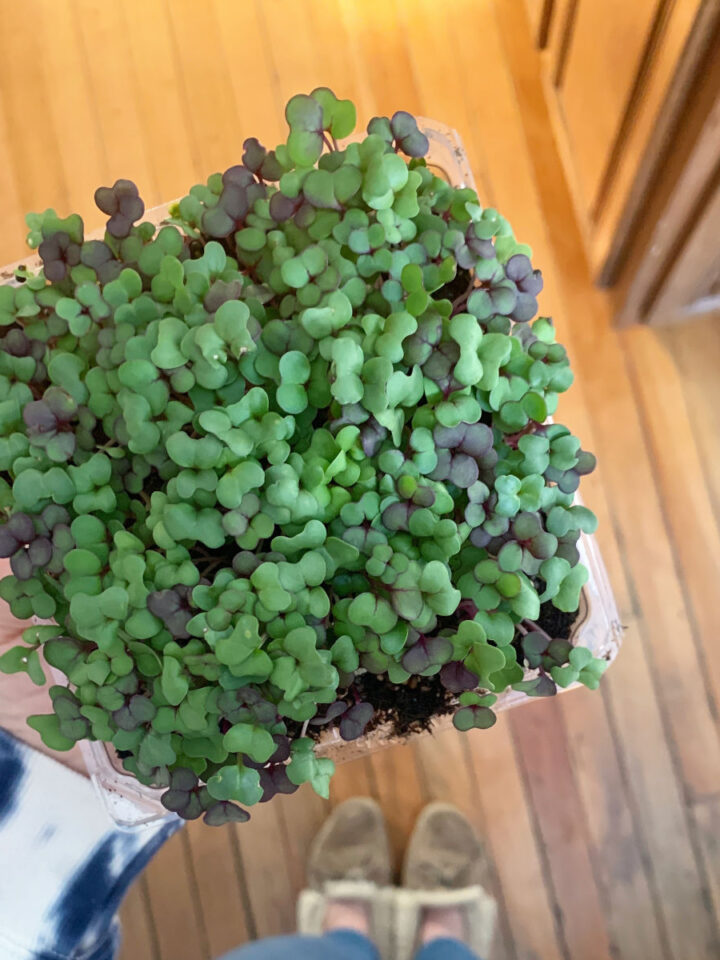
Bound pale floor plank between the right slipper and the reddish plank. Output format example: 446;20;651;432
465;716;568;960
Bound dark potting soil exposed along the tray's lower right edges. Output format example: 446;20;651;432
307;601;578;738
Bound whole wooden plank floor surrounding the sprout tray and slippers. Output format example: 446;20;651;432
0;0;720;960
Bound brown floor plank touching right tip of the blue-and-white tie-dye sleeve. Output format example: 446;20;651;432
145;830;209;960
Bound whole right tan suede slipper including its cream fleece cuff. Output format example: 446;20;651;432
393;803;497;960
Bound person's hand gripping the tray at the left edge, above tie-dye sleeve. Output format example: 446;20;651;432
0;560;87;774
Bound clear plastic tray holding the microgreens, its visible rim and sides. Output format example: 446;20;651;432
9;117;622;828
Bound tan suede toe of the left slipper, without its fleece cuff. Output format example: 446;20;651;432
307;797;392;890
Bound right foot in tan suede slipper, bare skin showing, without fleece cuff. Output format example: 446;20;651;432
403;803;488;943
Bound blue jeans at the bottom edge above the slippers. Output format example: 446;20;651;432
222;930;478;960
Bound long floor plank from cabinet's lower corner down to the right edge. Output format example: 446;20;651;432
552;182;720;797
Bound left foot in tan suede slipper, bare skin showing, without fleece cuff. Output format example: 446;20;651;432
307;797;392;934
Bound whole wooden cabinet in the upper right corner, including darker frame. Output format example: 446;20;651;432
526;0;720;321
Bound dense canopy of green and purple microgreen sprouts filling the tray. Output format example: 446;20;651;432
0;88;605;823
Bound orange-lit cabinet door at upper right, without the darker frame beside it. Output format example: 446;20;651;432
529;0;720;283
